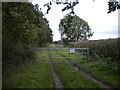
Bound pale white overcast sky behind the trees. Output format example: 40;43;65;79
32;0;118;41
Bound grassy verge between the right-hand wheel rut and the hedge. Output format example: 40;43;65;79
56;50;120;88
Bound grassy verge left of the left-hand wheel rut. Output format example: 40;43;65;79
3;49;54;88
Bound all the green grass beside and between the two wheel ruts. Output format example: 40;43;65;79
3;47;119;88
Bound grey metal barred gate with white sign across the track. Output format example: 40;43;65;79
34;48;89;59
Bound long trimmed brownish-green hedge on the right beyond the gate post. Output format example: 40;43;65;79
70;38;119;62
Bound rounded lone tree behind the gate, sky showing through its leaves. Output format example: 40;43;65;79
59;14;93;44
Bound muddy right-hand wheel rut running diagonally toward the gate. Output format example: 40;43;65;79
59;53;114;90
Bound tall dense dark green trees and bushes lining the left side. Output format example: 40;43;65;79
2;2;52;72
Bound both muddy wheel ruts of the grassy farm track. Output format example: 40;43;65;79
37;47;113;90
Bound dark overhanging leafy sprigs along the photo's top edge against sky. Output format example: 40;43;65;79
34;0;120;15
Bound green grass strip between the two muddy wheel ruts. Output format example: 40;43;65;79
52;50;100;88
